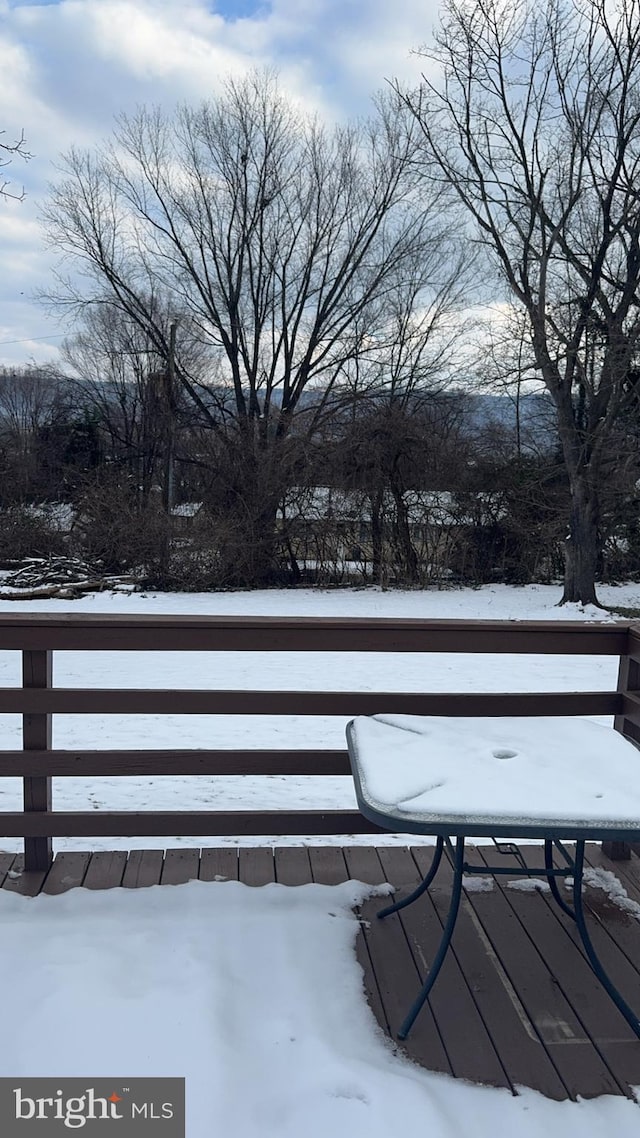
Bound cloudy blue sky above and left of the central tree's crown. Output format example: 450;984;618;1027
0;0;437;364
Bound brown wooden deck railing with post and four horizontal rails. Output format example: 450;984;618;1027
0;613;640;869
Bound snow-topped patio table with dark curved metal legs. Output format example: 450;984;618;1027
346;715;640;1039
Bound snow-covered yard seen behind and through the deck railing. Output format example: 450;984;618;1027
0;585;640;850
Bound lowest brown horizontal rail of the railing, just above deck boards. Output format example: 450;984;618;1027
0;810;384;838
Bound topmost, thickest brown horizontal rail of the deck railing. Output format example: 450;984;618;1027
0;613;629;655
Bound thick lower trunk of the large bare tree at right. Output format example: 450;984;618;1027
560;477;601;608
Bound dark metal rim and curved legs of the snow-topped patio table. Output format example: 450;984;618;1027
346;723;640;1039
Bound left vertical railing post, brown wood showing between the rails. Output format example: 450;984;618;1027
23;651;54;869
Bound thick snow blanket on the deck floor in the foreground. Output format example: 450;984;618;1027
0;882;640;1138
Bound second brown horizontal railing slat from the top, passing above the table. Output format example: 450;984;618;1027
0;687;622;716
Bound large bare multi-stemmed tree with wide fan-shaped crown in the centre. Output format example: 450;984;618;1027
39;75;457;580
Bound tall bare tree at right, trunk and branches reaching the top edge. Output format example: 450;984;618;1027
396;0;640;603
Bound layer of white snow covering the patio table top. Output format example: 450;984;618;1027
353;715;640;836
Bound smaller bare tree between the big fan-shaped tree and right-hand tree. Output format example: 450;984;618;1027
323;259;473;585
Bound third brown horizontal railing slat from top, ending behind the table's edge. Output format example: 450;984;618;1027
0;750;351;778
